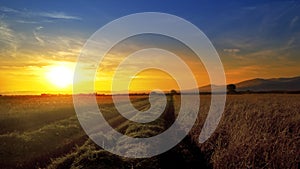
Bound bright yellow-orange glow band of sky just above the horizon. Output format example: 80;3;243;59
0;54;299;94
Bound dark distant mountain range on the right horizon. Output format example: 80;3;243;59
199;76;300;92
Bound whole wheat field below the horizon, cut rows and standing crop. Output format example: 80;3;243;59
0;94;300;168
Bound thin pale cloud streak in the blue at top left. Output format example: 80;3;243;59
0;6;81;20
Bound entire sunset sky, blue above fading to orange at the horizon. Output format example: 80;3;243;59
0;0;300;94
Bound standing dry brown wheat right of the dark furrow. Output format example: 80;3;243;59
179;94;300;168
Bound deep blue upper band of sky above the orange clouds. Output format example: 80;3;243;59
0;0;300;44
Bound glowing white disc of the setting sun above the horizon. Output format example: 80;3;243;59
46;65;73;88
